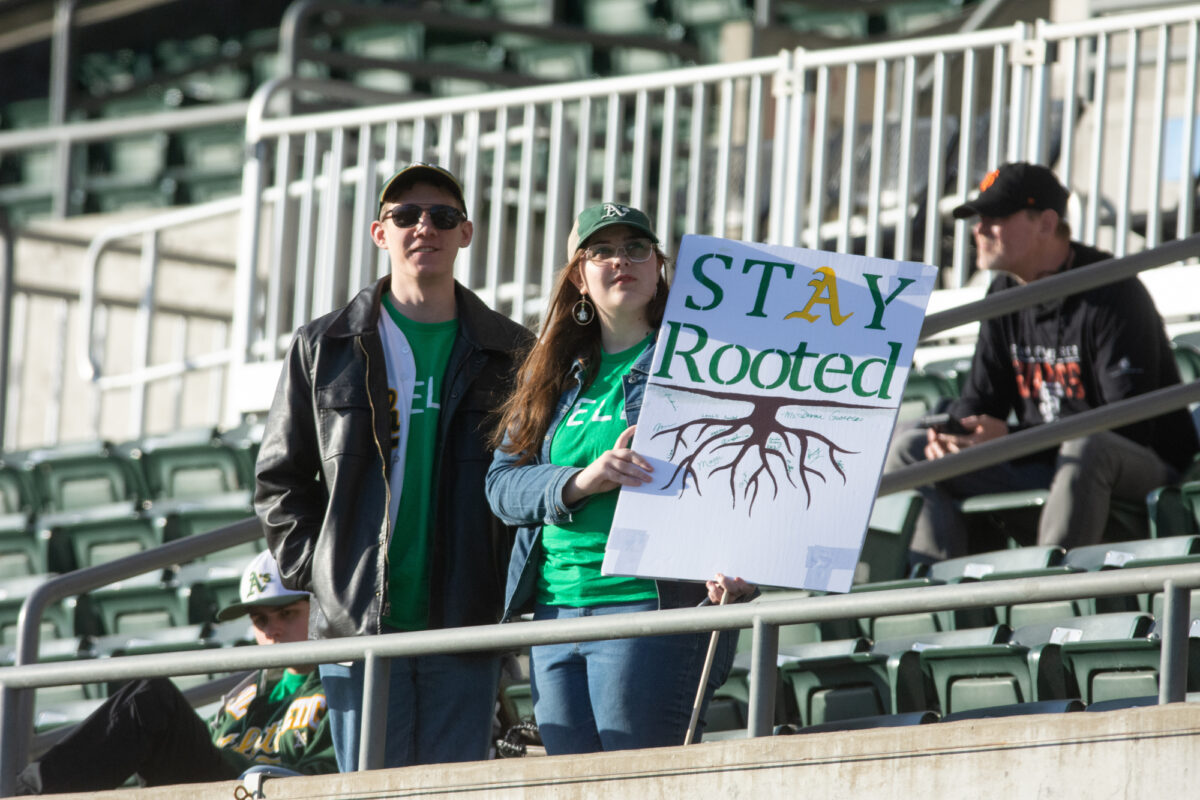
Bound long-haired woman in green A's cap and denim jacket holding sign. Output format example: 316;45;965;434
487;203;754;754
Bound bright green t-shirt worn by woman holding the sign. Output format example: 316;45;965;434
538;337;658;606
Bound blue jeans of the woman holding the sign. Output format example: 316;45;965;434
529;600;737;756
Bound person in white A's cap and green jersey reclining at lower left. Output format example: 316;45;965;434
17;551;337;794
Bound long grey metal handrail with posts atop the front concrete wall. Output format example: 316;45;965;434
0;564;1200;792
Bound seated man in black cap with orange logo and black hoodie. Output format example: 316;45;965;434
884;163;1200;561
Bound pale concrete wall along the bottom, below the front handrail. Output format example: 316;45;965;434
63;704;1200;800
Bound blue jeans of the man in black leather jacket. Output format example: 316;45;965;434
320;655;500;772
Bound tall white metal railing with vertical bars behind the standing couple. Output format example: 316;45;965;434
234;4;1200;369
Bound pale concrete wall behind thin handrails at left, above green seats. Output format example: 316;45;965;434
0;211;236;450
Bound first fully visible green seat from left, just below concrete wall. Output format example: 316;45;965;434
26;441;146;511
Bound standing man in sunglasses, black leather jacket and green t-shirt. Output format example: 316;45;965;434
254;163;532;771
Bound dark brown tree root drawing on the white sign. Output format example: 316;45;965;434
650;386;875;512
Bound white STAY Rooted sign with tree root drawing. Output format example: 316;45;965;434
602;236;936;591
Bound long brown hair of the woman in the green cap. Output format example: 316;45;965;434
492;245;668;464
